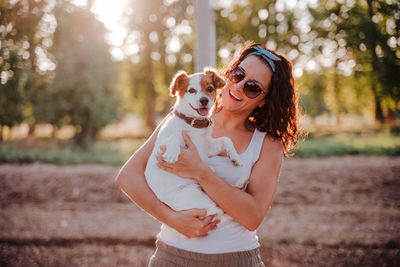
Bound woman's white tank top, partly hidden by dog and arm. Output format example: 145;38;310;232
157;130;265;254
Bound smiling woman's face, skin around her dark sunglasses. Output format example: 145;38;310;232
221;55;272;115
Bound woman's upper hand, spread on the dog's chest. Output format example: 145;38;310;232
156;131;208;180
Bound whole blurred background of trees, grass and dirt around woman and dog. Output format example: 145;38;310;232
0;0;400;266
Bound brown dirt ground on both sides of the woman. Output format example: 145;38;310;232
0;156;400;266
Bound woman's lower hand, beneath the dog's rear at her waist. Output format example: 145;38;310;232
168;209;220;238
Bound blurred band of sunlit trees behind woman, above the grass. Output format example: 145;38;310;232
0;0;400;147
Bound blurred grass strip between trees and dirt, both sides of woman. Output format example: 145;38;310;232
0;133;400;165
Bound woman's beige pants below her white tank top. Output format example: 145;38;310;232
148;240;264;267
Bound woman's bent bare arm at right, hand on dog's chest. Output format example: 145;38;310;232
158;132;283;231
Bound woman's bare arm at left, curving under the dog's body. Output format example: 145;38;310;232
115;119;219;240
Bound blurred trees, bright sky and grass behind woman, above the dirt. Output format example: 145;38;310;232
0;0;400;161
